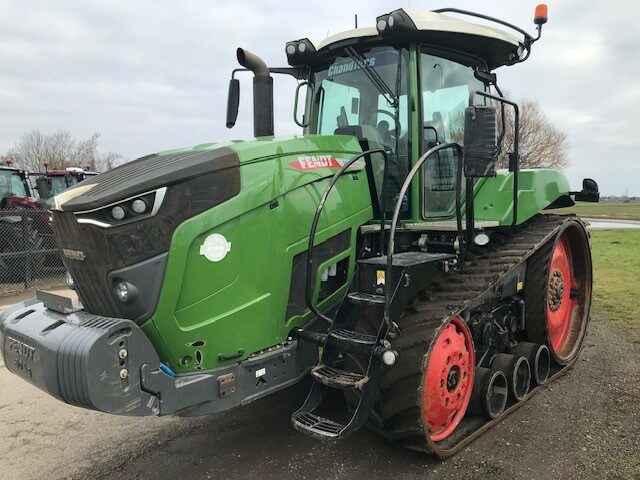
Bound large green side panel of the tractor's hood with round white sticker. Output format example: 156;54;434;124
144;136;373;373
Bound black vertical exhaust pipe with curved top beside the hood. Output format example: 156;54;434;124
236;48;273;137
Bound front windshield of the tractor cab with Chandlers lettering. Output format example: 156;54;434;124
309;46;409;216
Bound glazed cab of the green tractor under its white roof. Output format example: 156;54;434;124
285;9;528;222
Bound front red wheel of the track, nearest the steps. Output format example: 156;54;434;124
422;317;475;442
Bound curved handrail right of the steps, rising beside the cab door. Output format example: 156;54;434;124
383;142;464;328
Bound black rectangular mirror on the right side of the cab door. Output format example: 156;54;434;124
463;105;497;178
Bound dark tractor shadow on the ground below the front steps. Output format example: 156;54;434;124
91;382;440;480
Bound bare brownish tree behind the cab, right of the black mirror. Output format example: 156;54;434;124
497;98;569;170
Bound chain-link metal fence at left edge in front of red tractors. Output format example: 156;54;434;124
0;209;66;297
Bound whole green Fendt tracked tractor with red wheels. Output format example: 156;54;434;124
0;5;599;458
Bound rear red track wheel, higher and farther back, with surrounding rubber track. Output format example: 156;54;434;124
525;219;592;365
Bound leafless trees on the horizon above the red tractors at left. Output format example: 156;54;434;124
7;130;124;172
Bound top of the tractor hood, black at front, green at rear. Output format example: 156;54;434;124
52;135;360;213
